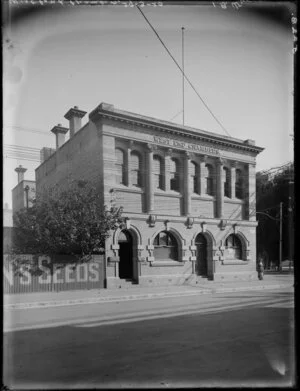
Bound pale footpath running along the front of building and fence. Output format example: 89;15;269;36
3;273;294;310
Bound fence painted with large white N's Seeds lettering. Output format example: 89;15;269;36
3;254;105;293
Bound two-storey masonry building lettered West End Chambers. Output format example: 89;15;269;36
36;103;263;288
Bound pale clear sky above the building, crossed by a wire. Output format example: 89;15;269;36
3;1;294;207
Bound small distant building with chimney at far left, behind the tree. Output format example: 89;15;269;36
12;165;35;214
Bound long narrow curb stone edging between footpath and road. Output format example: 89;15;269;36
3;283;294;310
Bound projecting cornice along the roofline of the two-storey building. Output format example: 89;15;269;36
89;105;264;154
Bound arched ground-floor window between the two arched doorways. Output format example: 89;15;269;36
153;231;178;261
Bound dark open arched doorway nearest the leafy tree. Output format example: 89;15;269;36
118;230;133;280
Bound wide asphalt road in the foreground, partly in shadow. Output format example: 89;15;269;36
3;289;295;389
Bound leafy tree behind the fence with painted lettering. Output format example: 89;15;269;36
13;181;122;257
